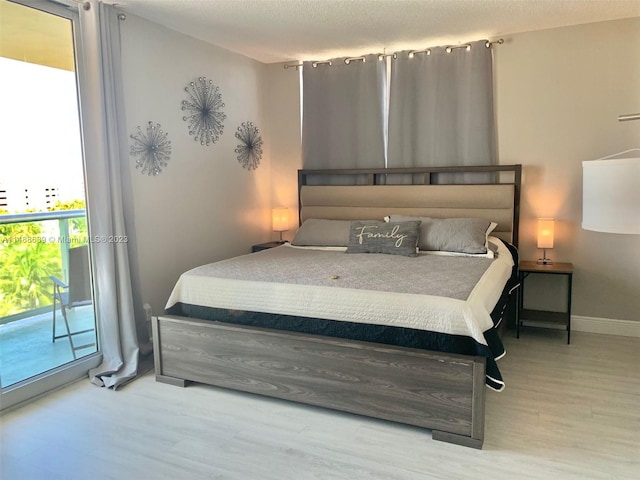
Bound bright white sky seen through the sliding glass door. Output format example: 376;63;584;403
0;57;84;213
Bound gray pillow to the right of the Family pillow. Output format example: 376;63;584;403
390;215;495;253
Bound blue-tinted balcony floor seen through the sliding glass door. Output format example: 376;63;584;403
0;305;96;387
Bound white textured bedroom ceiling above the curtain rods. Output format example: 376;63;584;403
115;0;640;63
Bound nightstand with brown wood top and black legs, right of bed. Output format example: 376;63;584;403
516;261;573;344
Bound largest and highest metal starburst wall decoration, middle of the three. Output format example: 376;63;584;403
182;77;227;145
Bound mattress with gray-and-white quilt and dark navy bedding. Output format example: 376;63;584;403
166;239;514;390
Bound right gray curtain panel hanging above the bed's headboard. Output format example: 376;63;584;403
388;40;497;183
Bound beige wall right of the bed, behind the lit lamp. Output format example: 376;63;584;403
494;18;640;321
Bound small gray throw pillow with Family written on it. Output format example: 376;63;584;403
347;220;420;257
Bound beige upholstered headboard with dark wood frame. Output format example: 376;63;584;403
298;165;521;246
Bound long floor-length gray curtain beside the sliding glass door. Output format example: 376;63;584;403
79;0;144;389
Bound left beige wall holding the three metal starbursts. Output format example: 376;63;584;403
121;14;271;313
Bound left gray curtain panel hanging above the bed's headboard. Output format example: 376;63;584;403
302;55;387;184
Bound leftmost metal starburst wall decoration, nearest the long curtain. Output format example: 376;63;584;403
130;122;171;175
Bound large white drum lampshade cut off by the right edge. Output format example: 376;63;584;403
582;158;640;234
